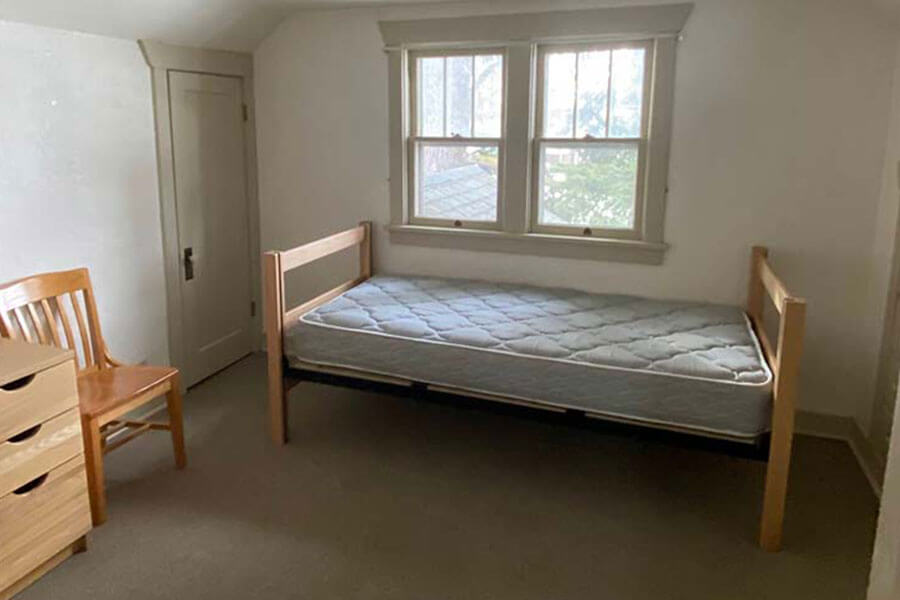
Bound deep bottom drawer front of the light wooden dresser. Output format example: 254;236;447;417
0;456;91;590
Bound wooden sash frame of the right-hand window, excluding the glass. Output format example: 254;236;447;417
528;37;653;240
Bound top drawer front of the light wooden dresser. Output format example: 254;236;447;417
0;360;78;440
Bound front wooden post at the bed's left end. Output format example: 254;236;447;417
263;252;287;445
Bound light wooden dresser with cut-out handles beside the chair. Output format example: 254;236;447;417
0;338;91;600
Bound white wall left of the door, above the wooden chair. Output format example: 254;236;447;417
0;22;168;363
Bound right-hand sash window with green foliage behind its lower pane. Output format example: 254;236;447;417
532;41;651;239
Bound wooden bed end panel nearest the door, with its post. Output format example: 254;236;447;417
263;221;372;445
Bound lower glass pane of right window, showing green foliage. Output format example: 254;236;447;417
538;143;638;229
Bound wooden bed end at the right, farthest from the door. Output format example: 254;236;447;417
747;246;806;552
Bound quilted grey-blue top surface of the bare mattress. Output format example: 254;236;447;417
301;276;771;385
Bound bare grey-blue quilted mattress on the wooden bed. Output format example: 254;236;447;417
284;276;772;441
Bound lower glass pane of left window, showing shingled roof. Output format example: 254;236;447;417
416;143;498;221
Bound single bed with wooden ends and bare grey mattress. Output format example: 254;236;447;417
264;223;804;550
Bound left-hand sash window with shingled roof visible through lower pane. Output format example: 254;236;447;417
409;49;505;229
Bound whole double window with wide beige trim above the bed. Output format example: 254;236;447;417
379;4;692;264
